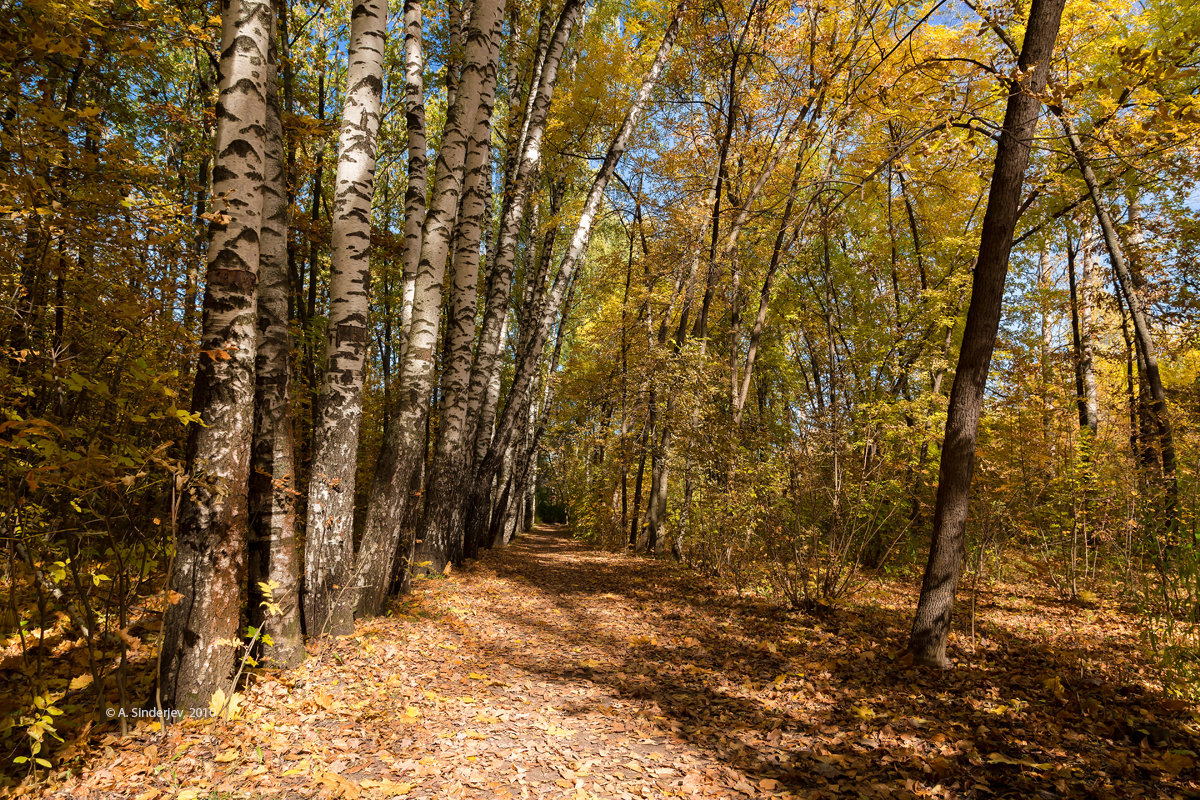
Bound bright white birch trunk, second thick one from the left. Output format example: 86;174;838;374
305;0;388;637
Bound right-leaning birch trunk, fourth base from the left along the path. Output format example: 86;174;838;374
355;0;504;616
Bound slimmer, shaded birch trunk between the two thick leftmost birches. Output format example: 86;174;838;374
248;31;305;668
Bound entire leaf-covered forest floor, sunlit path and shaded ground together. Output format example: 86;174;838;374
9;528;1200;800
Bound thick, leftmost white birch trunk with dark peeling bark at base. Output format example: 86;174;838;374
158;0;271;709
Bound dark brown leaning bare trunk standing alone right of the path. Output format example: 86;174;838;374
908;0;1064;667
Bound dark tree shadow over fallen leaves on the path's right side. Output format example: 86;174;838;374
453;528;1200;798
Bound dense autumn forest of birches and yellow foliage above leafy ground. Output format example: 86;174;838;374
0;0;1200;782
